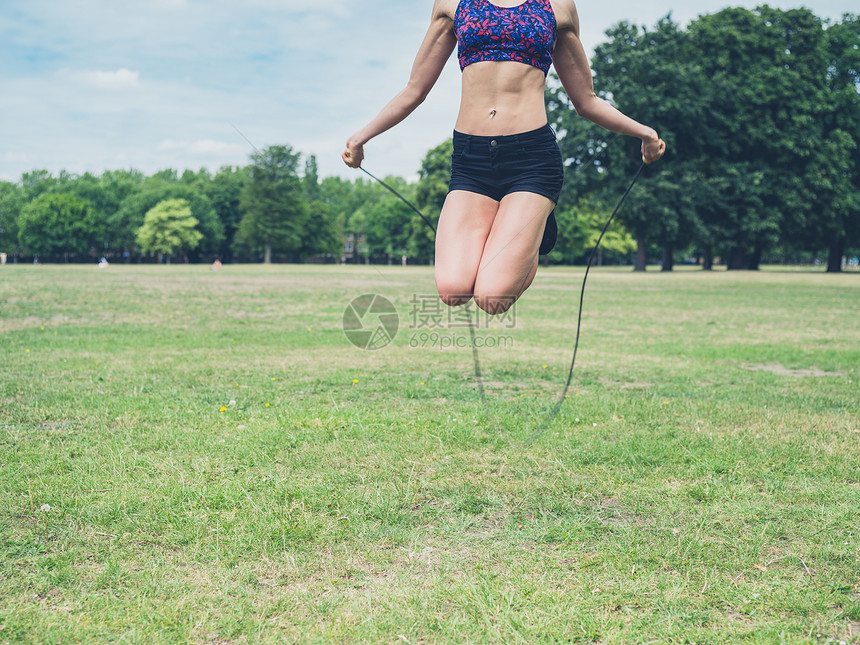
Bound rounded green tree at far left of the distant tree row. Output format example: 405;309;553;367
18;193;104;261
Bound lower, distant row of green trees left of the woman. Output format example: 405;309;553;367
0;145;450;263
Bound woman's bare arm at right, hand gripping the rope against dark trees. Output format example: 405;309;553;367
553;0;666;163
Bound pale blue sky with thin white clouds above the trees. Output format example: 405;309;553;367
0;0;856;181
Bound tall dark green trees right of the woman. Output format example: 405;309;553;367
547;5;860;271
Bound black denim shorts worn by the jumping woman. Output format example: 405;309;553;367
448;124;564;255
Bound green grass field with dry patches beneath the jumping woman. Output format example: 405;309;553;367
0;265;860;644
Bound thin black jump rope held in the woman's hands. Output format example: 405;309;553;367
361;148;646;447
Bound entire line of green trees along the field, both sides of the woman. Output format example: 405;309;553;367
0;6;860;271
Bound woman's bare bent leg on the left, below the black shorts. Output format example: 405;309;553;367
435;190;499;307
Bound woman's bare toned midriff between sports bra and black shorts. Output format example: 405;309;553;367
454;61;547;136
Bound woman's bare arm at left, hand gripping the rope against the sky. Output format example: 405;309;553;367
342;0;457;168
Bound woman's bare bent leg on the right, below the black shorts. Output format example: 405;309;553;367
473;192;555;314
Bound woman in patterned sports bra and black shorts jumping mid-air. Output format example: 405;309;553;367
343;0;666;314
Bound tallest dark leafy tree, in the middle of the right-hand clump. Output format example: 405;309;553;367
688;5;826;269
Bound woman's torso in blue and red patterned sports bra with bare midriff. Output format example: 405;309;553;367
449;0;557;136
